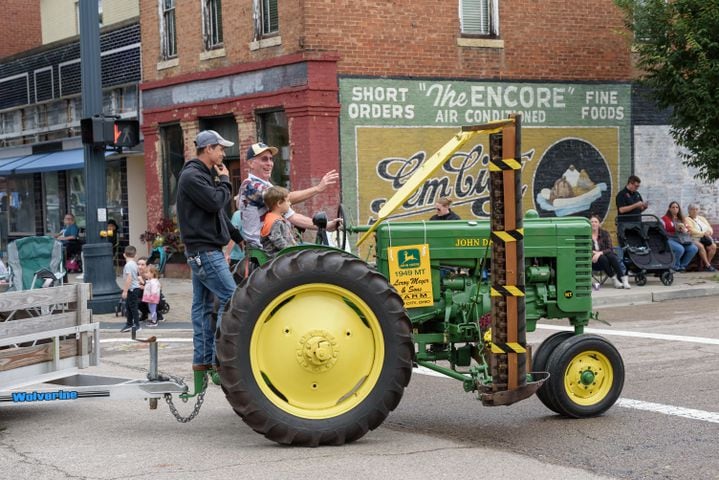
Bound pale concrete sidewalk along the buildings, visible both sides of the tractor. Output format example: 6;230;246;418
87;272;719;331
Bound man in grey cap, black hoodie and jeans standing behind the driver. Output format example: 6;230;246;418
177;130;242;372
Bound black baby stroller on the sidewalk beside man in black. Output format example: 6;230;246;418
617;215;674;287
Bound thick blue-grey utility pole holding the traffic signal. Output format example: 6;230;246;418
79;0;120;313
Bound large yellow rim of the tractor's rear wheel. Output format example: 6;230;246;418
250;283;384;419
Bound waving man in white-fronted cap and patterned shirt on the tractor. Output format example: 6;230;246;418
237;143;340;248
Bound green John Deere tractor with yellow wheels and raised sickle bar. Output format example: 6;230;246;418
217;117;624;446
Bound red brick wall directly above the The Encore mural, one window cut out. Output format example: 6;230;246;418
304;0;631;80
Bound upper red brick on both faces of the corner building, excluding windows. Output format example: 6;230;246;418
142;0;632;81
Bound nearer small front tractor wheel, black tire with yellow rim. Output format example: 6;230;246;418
543;335;624;418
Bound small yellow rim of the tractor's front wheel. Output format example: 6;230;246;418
564;350;614;406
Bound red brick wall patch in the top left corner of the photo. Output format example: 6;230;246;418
0;0;42;59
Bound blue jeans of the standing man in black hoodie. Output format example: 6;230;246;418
186;250;236;365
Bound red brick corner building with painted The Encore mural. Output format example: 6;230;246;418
141;0;716;242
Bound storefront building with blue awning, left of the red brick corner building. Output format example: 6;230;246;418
0;0;147;251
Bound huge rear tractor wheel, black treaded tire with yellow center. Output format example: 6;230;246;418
217;250;414;446
